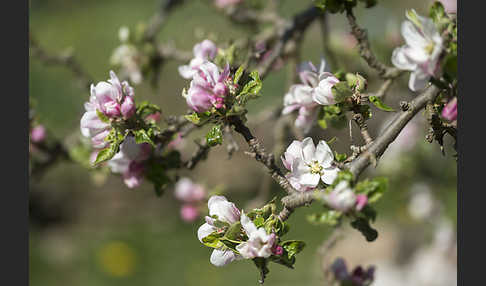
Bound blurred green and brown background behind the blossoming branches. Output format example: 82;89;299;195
29;0;457;286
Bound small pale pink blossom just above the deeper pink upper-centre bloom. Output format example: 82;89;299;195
179;40;218;79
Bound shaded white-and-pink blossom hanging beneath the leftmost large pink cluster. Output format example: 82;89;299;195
108;136;151;188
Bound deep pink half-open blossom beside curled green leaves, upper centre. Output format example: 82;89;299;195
183;61;233;112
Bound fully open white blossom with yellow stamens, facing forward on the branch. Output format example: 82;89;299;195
282;137;339;191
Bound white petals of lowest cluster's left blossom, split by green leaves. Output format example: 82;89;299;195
197;196;240;266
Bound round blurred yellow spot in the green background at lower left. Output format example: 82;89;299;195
98;241;136;277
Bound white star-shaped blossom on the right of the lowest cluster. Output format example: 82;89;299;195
236;213;276;259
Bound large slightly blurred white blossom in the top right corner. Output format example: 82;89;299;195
392;10;442;91
